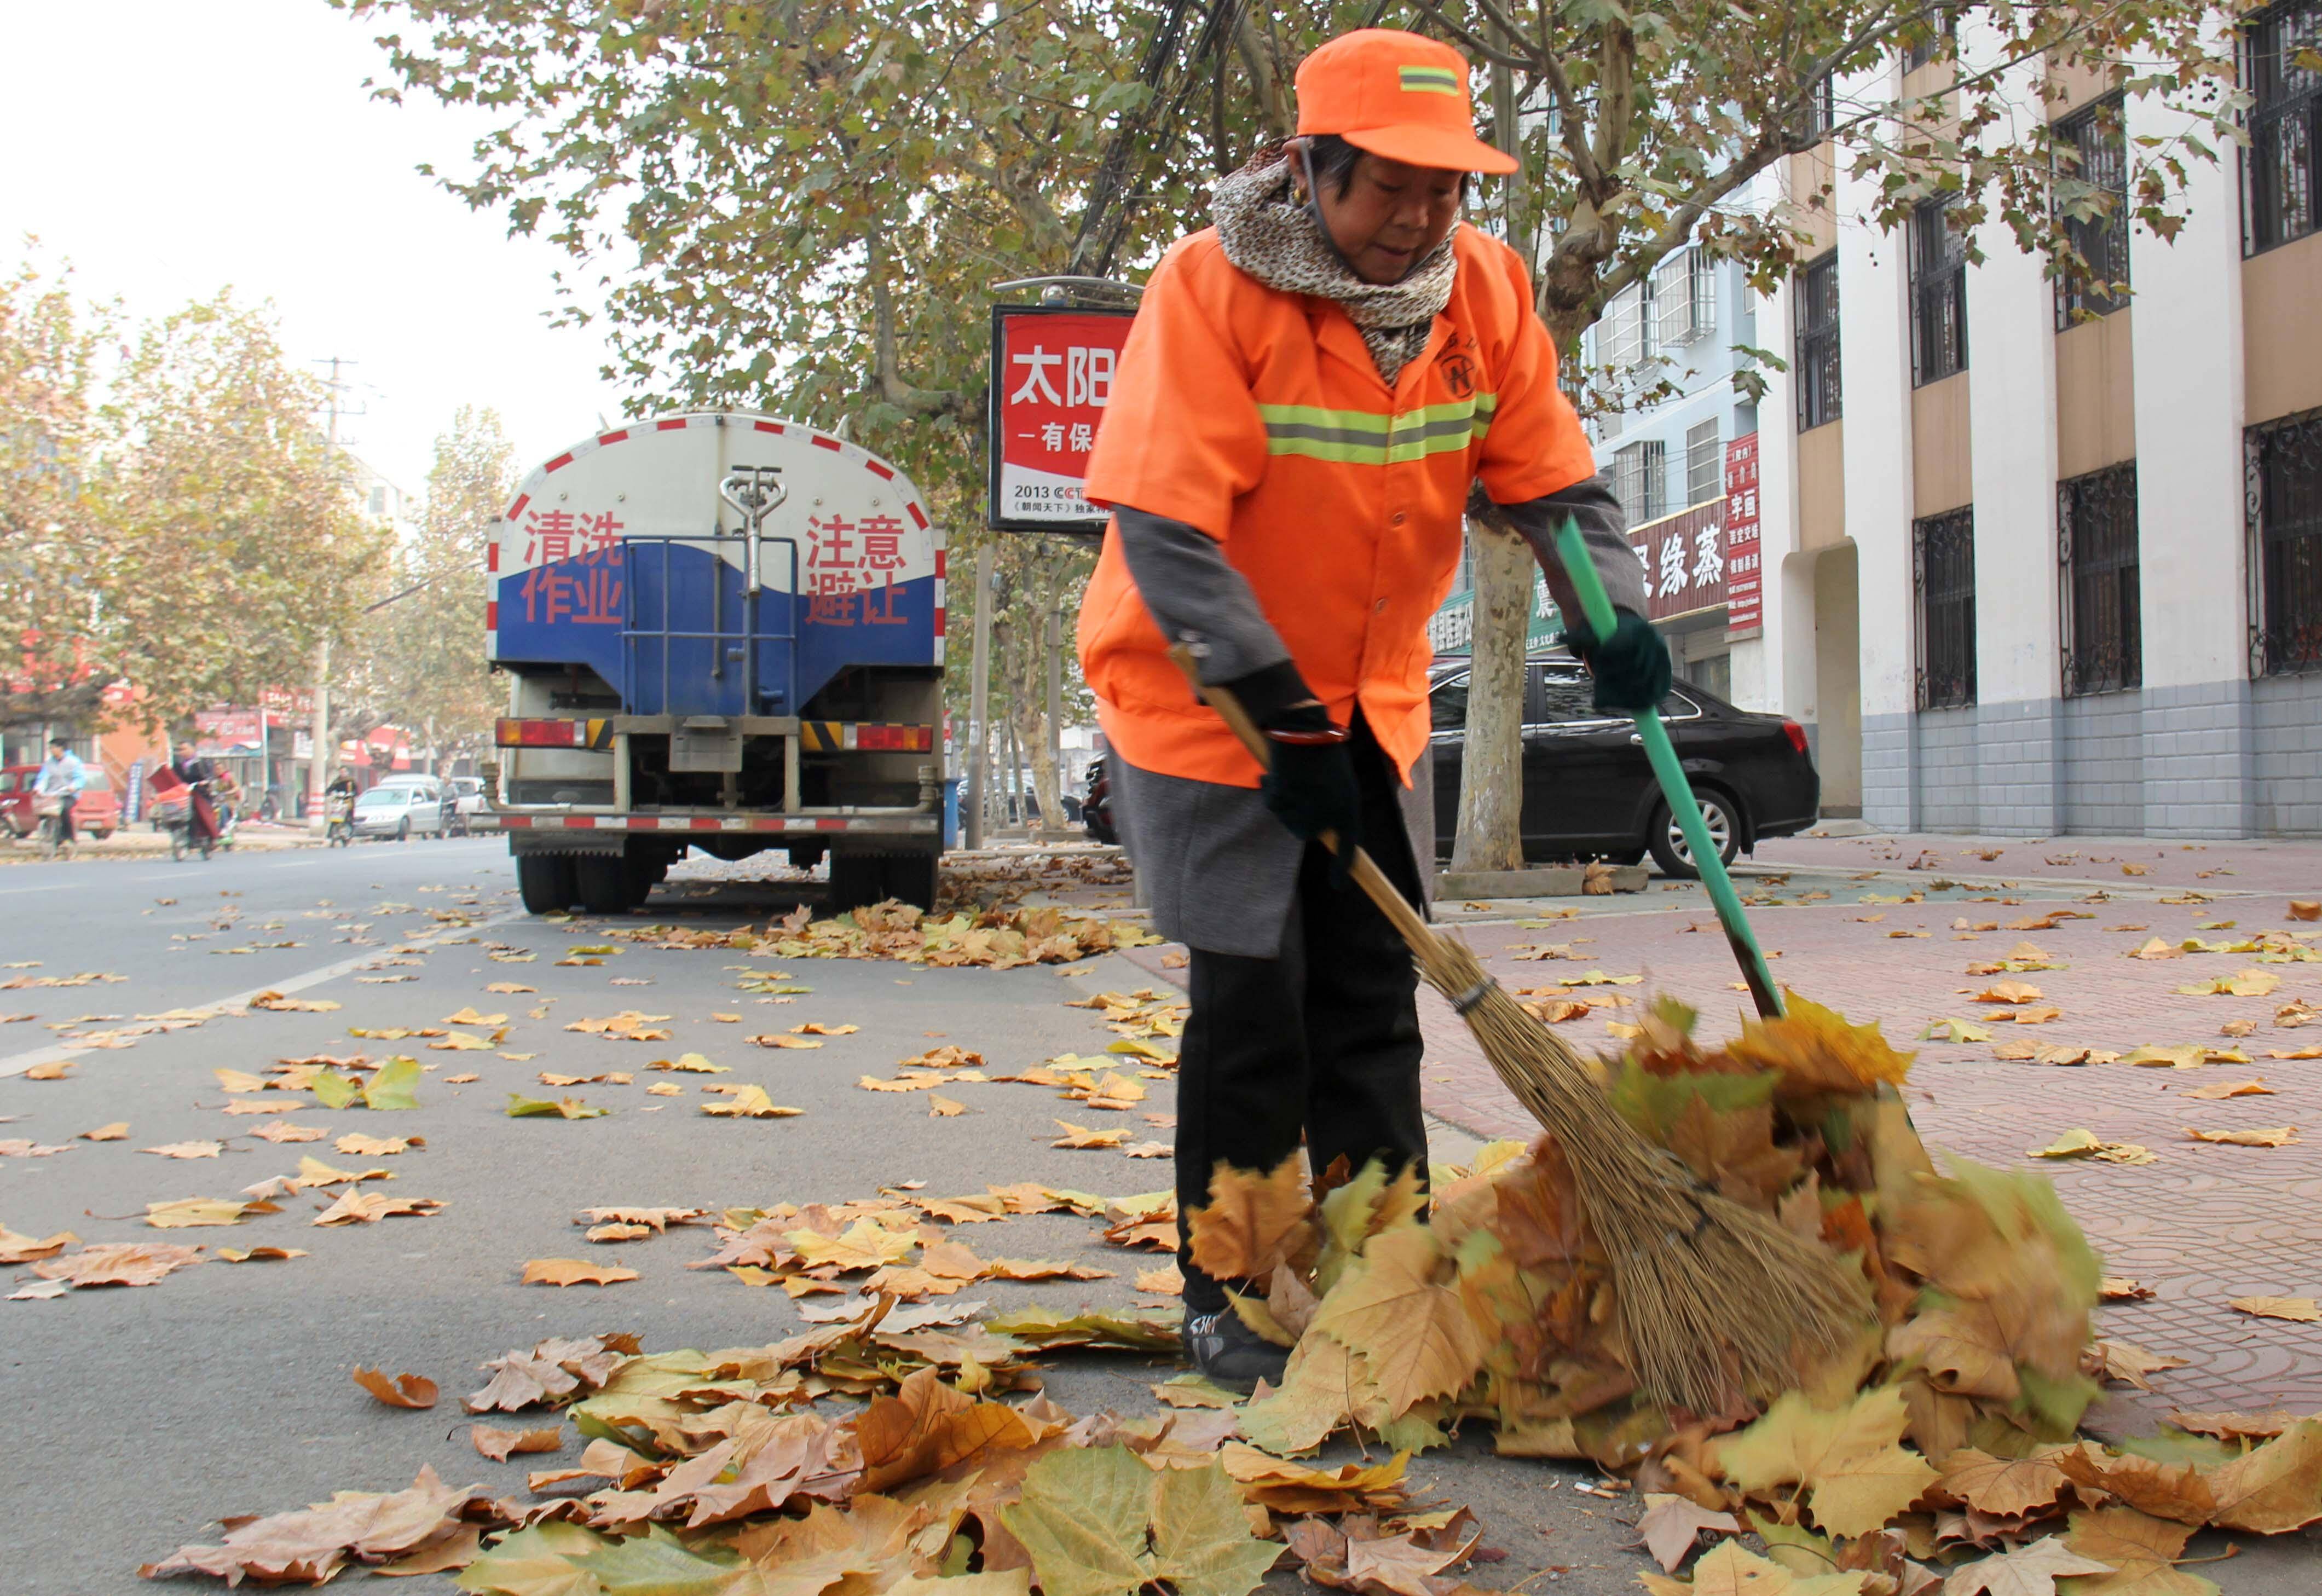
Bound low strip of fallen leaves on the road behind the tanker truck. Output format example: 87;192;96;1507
602;899;1161;969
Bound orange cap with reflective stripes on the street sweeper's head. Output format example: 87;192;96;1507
1298;28;1516;174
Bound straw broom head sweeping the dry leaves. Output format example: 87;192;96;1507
1414;934;1869;1413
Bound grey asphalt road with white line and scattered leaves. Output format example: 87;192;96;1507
0;841;2311;1596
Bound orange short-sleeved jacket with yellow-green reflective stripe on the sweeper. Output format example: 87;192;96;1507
1080;225;1595;788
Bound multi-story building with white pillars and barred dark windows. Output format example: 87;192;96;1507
1523;12;2322;836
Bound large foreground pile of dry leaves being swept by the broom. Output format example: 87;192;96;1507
146;999;2322;1596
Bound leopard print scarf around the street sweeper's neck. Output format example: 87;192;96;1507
1210;144;1458;386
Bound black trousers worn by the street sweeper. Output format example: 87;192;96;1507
1177;715;1428;1312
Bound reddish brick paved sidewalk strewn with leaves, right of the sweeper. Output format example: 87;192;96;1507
1135;887;2322;1417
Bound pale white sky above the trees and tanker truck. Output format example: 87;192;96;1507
0;0;622;493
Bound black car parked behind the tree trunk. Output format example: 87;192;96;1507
1430;653;1823;876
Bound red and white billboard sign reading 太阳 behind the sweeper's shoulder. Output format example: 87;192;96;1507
987;304;1135;532
